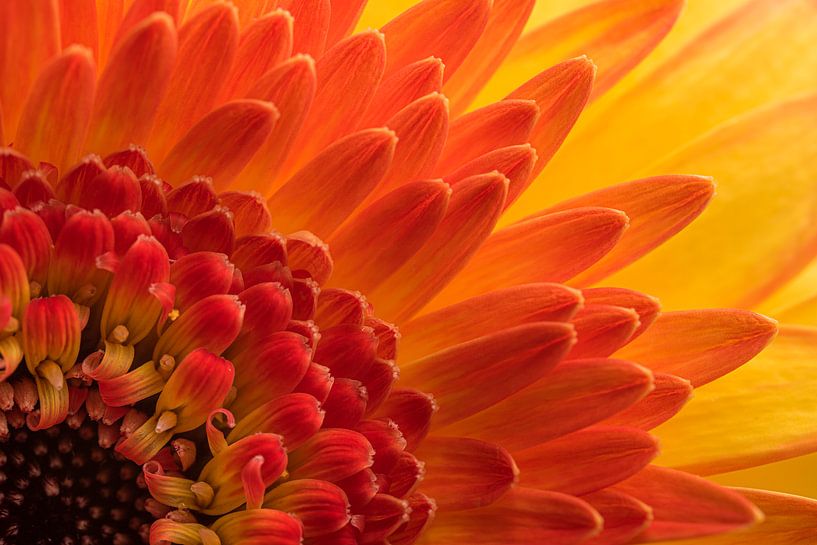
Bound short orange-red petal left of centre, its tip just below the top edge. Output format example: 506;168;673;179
221;10;293;99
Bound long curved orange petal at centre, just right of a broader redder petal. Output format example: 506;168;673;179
367;172;508;321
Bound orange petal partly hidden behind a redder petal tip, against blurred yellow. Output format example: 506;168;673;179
548;176;715;286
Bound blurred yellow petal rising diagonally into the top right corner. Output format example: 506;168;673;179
516;0;817;217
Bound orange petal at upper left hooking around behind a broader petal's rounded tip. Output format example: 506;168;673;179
233;55;317;196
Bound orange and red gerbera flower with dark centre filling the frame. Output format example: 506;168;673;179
0;0;817;545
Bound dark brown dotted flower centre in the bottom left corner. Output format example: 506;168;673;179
0;419;153;545
